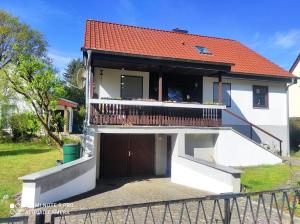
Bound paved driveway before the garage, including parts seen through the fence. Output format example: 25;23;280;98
19;178;299;224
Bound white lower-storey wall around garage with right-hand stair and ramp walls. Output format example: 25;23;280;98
87;126;282;193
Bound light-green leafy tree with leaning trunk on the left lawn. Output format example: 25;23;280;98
4;55;64;146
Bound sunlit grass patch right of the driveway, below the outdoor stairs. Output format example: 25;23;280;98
241;164;300;192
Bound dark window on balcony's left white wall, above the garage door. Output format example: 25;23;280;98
121;75;143;99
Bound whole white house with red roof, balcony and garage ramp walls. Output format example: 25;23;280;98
21;20;293;207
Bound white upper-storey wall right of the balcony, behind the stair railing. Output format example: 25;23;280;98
203;77;290;155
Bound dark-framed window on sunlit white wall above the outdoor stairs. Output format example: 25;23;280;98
253;86;269;108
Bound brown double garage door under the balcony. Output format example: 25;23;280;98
100;134;154;178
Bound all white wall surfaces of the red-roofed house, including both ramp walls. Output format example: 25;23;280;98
18;68;289;207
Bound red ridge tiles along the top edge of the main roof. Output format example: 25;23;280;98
86;19;237;42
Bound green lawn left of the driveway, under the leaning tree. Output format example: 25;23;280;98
0;142;61;217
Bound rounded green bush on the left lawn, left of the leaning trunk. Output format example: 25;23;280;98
9;112;40;141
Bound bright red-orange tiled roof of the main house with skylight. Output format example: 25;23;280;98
83;20;292;77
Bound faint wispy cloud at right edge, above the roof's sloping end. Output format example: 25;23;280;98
274;30;300;49
